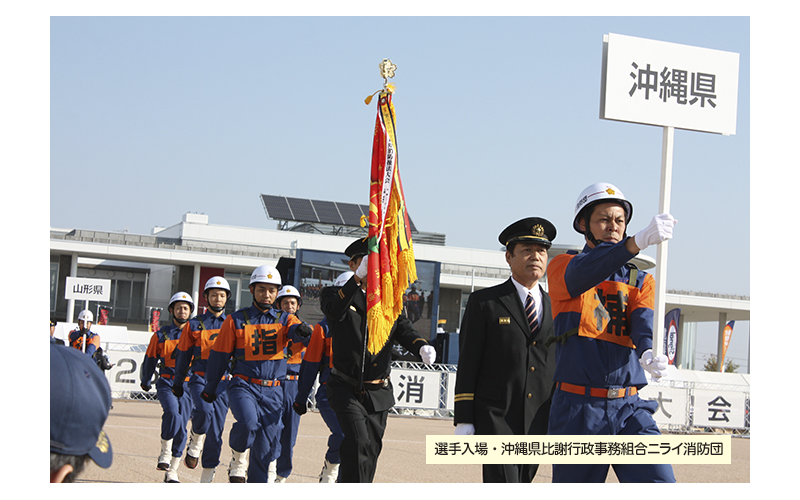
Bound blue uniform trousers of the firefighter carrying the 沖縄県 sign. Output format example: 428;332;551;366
548;389;675;483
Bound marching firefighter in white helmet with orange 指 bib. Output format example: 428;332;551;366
200;265;311;483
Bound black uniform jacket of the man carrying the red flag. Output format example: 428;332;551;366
320;277;428;412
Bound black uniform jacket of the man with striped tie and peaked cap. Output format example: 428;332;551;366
453;279;555;435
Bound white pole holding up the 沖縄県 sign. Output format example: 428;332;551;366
653;127;675;356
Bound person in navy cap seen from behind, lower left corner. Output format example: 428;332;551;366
50;343;113;483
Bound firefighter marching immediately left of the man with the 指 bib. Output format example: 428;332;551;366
172;276;231;483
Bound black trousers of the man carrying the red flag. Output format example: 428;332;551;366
327;375;389;483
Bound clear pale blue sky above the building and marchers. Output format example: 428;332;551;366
43;13;750;370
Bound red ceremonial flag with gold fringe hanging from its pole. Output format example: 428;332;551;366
367;90;417;354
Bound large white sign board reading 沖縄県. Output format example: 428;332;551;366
600;33;739;135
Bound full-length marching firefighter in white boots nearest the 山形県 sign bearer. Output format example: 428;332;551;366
141;292;194;483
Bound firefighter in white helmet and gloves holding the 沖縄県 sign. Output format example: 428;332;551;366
548;182;677;483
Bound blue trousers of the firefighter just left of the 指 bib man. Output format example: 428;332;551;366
189;374;229;469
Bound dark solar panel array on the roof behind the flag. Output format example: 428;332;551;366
261;194;417;232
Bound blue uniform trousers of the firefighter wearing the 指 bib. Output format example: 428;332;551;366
227;378;283;482
